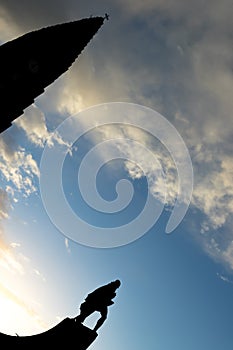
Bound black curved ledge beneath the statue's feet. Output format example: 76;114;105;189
0;318;98;350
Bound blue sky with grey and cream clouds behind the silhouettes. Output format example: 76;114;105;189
0;0;233;350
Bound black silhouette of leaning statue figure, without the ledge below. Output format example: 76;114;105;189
75;280;121;332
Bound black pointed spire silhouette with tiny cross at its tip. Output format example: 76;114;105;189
0;17;105;133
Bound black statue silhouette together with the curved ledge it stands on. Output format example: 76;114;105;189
0;280;121;350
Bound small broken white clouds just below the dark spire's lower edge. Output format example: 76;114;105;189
0;105;70;202
